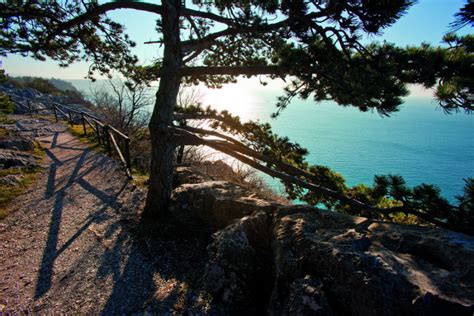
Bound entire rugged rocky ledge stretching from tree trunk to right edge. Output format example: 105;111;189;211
173;169;474;315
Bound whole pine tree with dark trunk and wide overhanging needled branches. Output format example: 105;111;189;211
0;0;473;226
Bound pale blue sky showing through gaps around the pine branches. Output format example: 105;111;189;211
0;0;470;79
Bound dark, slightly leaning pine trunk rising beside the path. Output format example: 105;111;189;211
143;0;182;220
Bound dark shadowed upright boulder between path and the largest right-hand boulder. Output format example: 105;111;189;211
203;211;271;314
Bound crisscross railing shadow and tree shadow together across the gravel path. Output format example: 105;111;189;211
34;132;206;315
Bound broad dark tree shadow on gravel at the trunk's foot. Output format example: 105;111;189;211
97;211;211;315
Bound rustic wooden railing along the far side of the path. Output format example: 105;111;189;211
9;94;133;179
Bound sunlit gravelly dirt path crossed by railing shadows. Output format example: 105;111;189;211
0;118;209;314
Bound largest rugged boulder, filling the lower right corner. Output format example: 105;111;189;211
269;206;474;315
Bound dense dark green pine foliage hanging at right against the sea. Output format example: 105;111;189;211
275;35;474;115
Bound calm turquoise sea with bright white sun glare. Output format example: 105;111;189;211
70;79;474;202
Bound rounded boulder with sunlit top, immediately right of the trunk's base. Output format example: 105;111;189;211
170;181;275;232
